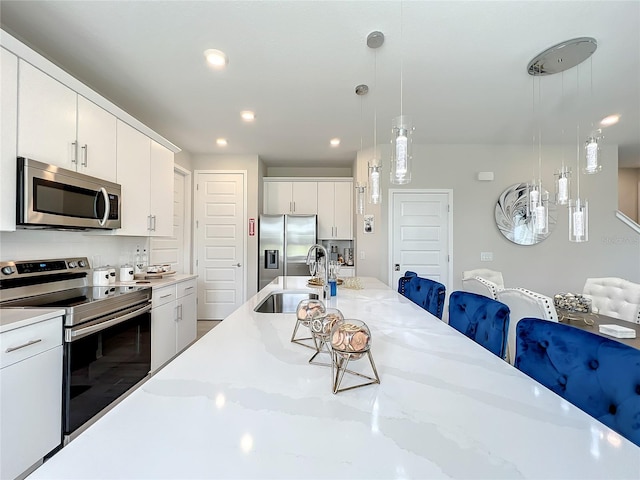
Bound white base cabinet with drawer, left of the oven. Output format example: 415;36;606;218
0;316;62;479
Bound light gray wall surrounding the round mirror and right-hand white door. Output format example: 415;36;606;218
355;145;640;295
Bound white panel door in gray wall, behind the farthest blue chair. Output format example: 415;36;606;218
389;190;452;292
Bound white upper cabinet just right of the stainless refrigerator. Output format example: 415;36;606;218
318;181;353;240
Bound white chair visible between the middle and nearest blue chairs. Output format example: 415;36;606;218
496;288;558;365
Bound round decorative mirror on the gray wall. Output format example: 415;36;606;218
495;183;557;245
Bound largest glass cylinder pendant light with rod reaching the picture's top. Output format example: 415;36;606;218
390;2;414;185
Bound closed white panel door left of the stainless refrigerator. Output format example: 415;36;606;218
195;172;247;320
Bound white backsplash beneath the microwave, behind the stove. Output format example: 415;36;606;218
0;230;149;267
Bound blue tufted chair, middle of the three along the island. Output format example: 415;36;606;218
449;291;509;358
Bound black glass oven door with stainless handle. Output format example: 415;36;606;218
62;303;151;441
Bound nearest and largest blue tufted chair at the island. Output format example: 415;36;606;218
515;318;640;446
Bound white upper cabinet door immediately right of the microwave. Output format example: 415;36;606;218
116;121;150;236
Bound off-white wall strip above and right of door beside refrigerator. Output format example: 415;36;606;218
191;155;262;298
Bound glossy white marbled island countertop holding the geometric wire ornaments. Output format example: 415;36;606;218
30;277;640;479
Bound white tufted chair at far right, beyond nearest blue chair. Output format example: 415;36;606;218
582;277;640;323
